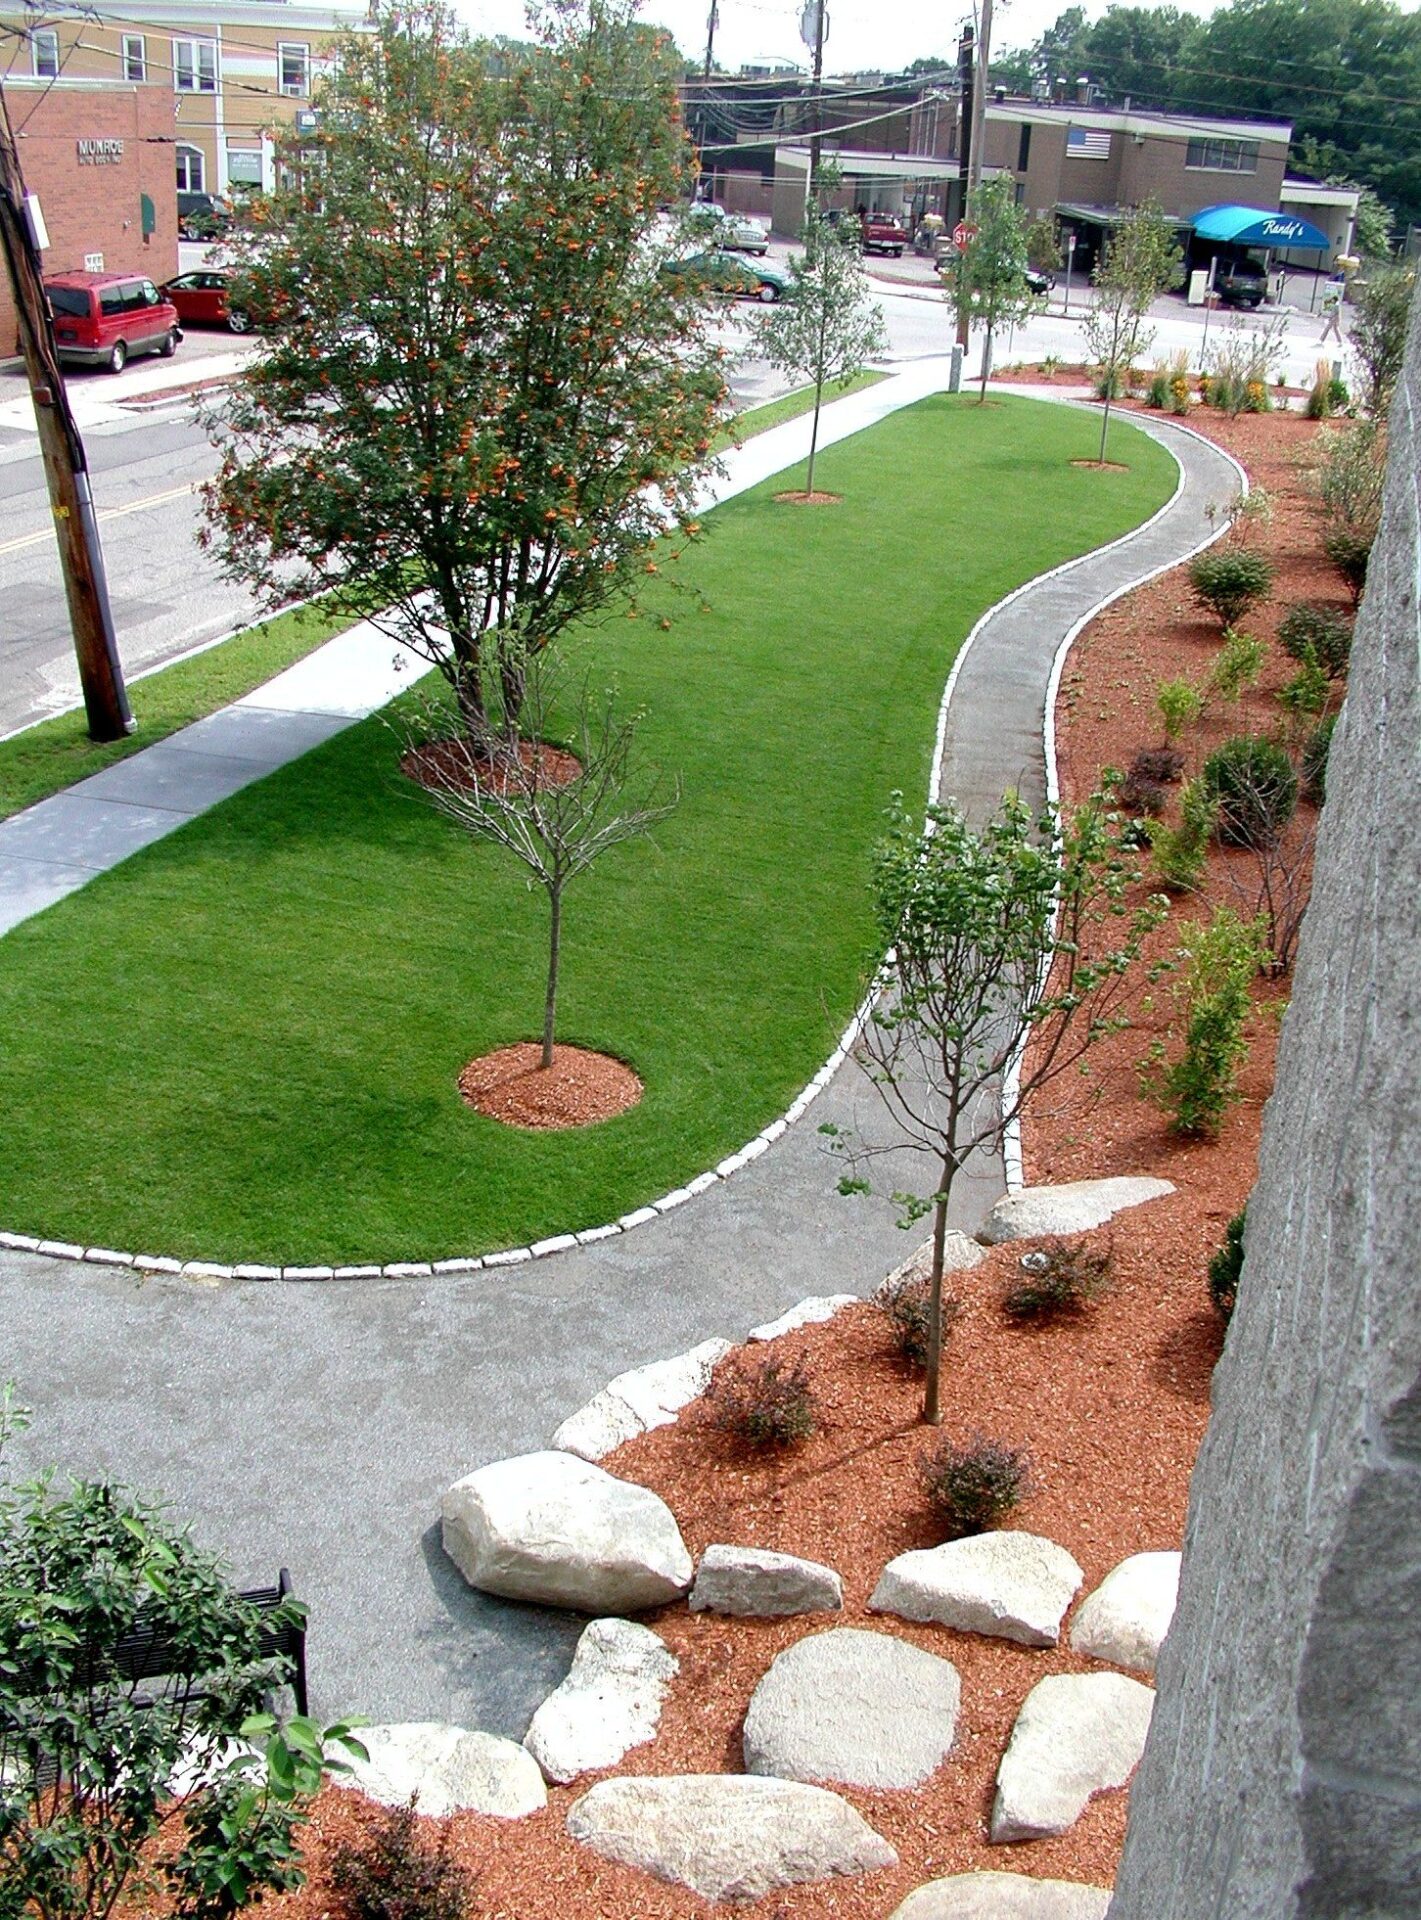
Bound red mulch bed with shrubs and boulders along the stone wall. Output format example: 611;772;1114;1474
240;397;1344;1920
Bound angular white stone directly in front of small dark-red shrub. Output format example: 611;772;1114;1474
868;1532;1085;1647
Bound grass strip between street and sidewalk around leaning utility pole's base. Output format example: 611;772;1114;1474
0;607;349;820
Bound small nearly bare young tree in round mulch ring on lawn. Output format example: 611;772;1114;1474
409;649;680;1068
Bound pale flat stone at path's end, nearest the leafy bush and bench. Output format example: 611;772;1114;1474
336;1720;547;1820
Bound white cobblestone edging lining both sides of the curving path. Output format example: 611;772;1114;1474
0;396;1248;1284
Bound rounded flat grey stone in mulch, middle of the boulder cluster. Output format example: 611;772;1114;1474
745;1626;962;1788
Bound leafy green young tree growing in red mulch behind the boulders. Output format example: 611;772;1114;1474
822;793;1168;1425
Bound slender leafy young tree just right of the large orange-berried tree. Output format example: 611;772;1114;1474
759;207;887;495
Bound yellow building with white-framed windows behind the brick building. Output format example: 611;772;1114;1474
0;0;369;194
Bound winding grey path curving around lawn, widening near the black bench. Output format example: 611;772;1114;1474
0;382;1239;1738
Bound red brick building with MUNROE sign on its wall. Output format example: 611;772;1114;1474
0;77;179;357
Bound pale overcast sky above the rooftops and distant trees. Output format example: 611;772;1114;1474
455;0;1216;73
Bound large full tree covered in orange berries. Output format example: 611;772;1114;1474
207;0;724;732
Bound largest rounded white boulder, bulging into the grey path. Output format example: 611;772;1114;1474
444;1452;695;1613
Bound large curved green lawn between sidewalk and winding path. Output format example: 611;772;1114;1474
0;397;1175;1261
